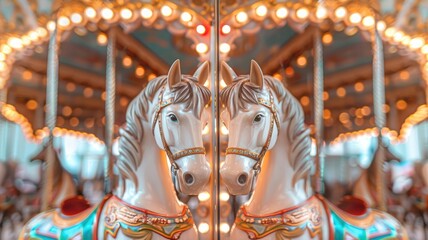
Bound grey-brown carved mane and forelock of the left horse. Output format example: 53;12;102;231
116;75;211;188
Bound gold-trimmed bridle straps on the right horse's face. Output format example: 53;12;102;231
226;92;280;190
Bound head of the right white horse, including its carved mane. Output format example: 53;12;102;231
220;60;311;194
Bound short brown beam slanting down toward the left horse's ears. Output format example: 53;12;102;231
115;28;169;74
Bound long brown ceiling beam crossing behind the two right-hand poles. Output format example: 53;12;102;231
290;57;418;97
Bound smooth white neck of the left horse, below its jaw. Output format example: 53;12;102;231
121;123;182;214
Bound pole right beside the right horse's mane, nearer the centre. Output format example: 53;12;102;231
314;29;324;194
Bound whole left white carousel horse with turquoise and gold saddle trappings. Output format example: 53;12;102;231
20;60;211;240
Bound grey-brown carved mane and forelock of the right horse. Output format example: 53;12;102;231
220;75;313;185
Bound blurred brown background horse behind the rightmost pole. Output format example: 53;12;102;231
352;144;401;207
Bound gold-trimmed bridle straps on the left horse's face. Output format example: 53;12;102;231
152;87;205;192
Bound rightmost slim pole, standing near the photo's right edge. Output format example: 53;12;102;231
372;19;386;211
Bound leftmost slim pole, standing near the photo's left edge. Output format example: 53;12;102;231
42;26;58;211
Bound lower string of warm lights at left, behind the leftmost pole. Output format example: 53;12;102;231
0;103;104;144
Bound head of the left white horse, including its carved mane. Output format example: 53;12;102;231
117;60;211;195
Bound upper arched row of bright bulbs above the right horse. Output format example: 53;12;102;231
226;3;428;87
